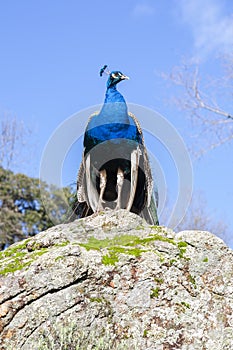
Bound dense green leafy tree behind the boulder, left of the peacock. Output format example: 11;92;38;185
0;167;73;250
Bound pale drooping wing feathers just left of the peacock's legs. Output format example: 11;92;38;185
85;154;98;212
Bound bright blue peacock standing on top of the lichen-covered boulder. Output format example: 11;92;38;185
75;65;158;225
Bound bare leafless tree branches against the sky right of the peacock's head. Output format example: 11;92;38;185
162;53;233;156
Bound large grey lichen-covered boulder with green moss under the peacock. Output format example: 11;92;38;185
0;210;233;350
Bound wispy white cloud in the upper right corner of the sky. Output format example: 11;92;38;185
176;0;233;58
